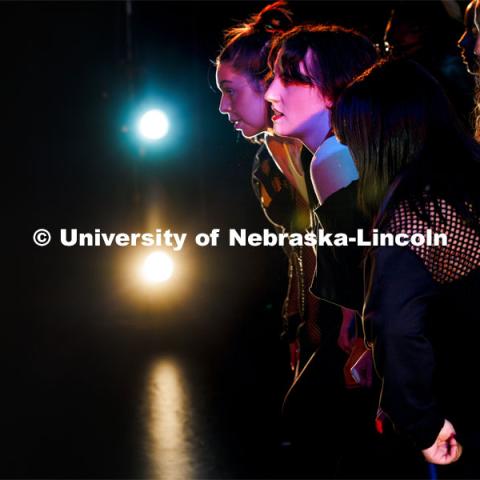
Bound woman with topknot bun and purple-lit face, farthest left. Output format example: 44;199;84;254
216;10;344;468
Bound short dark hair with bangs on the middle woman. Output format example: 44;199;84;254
269;25;377;102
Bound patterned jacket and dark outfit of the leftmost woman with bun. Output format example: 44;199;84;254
252;140;346;478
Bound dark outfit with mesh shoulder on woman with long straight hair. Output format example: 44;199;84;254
364;192;480;478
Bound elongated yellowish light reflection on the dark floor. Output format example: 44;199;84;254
147;358;196;480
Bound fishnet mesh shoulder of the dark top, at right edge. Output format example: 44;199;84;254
382;199;480;284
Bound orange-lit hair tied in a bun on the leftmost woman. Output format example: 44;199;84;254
216;1;292;85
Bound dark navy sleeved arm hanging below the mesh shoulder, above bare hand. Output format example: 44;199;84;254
364;247;445;450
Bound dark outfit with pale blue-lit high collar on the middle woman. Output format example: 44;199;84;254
311;135;383;478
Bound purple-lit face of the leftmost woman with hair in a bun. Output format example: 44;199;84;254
217;62;269;138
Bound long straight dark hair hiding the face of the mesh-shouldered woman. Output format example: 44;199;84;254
332;60;480;218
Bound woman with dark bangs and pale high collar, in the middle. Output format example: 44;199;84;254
265;25;380;477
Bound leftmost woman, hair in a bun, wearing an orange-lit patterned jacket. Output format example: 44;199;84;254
216;2;337;382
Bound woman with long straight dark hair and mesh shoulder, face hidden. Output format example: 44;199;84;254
332;60;480;478
